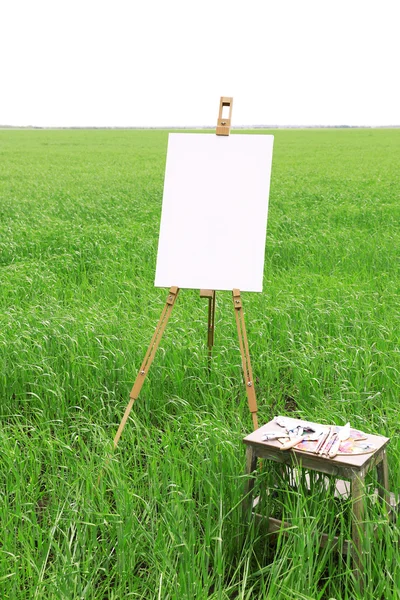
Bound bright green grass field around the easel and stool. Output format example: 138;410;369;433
0;130;400;600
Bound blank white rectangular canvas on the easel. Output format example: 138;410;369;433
155;133;274;292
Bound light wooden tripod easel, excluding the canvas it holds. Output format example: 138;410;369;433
114;96;258;448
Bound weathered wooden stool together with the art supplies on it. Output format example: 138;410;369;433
243;417;395;578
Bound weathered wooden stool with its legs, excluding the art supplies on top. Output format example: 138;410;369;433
243;420;390;576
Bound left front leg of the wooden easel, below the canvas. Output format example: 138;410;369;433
114;286;179;448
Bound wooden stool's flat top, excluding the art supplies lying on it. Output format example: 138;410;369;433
243;417;390;474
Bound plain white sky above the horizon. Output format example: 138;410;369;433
0;0;400;126
